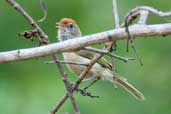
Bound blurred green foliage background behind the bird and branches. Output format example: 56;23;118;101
0;0;171;114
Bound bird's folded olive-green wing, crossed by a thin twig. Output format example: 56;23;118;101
75;47;112;70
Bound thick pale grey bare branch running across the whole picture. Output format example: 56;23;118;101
0;23;171;63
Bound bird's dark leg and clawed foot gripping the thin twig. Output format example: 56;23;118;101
76;77;100;98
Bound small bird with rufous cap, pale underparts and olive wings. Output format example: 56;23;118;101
57;18;144;100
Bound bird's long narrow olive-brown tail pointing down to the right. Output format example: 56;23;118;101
113;75;145;101
